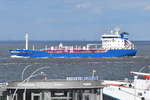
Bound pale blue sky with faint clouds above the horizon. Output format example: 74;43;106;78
0;0;150;41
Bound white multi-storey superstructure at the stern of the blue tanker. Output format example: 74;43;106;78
101;28;134;50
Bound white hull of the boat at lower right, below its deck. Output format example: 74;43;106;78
103;86;150;100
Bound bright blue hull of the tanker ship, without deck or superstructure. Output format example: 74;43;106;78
10;49;137;58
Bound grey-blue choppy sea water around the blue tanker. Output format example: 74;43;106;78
0;41;150;82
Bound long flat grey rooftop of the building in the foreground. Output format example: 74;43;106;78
7;80;104;89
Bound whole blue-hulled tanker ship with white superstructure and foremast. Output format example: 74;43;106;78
9;28;137;58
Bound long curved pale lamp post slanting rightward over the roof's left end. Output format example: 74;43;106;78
12;67;50;100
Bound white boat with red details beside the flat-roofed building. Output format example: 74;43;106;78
103;67;150;100
